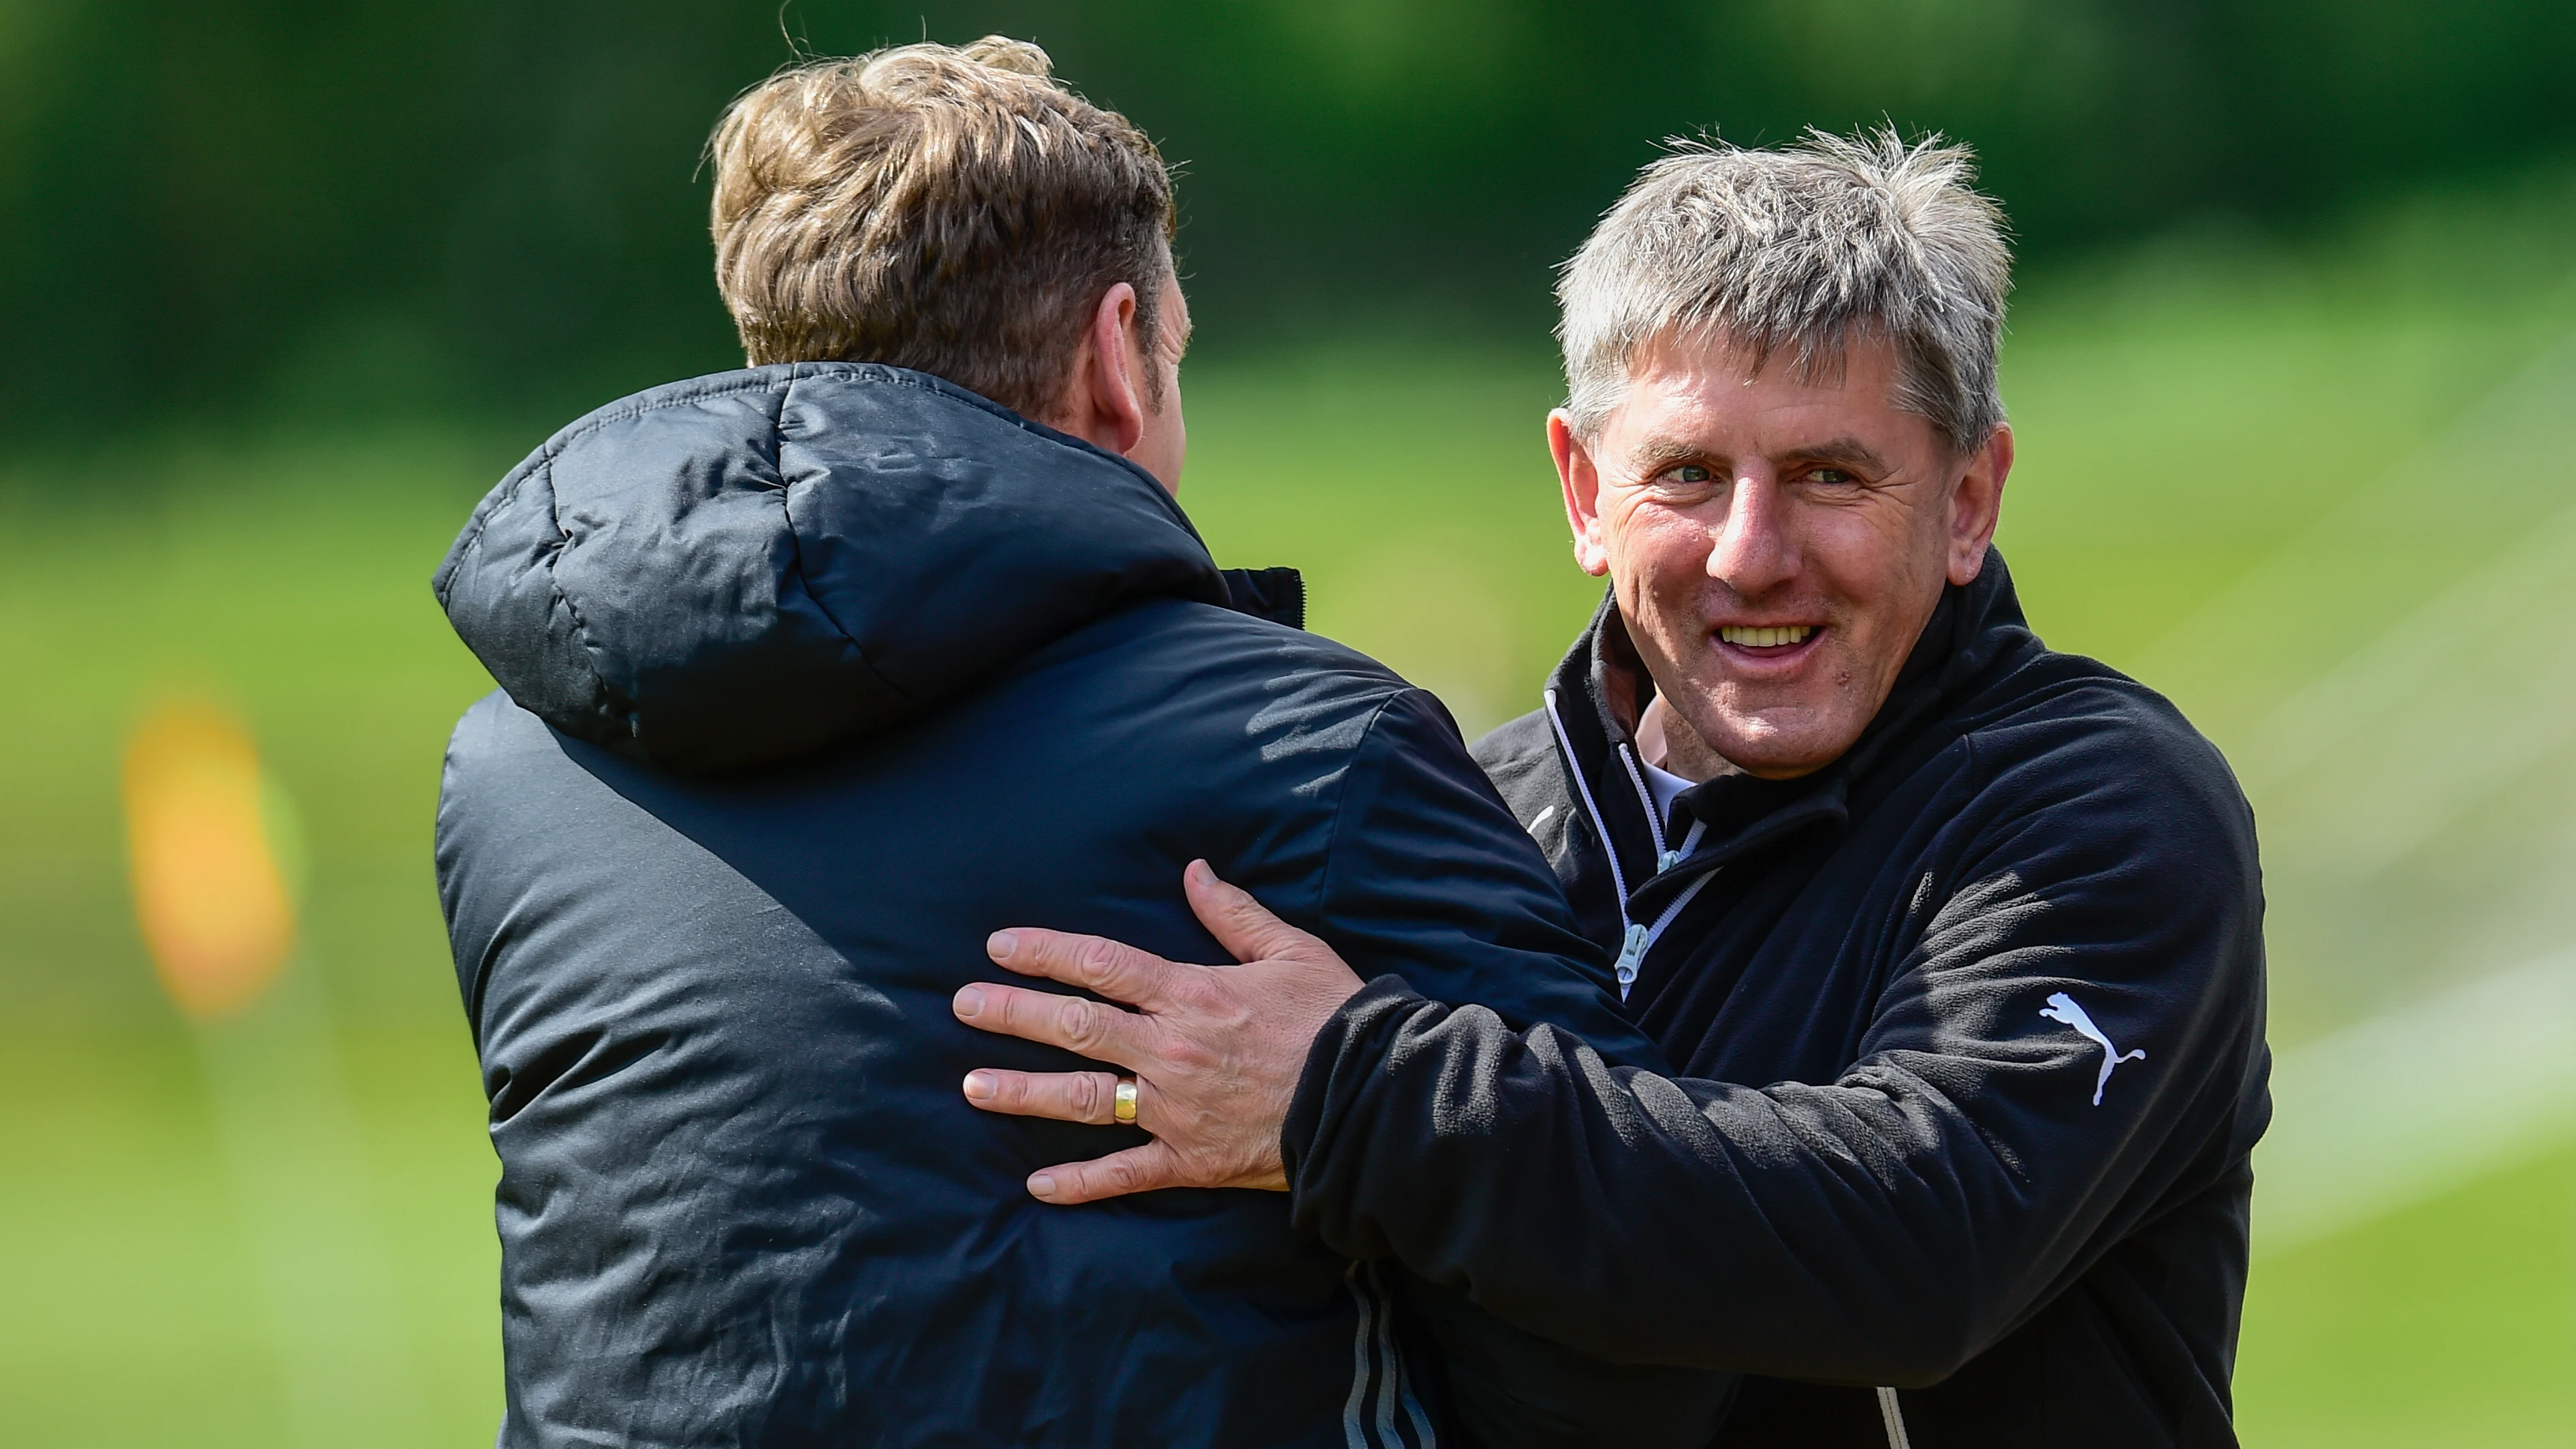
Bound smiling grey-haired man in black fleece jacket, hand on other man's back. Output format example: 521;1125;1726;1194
955;134;2270;1449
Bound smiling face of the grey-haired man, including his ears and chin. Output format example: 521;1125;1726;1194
1548;332;2012;780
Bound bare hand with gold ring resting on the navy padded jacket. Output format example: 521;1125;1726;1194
953;859;1360;1205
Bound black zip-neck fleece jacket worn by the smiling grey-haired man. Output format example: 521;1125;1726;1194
1286;554;2270;1449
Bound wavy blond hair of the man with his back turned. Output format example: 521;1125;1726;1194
708;36;1175;417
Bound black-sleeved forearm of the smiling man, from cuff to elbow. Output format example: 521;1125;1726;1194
1283;952;2256;1385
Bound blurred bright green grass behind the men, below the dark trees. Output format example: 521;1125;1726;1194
0;190;2576;1446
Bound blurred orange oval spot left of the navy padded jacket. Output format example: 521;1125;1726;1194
126;705;296;1019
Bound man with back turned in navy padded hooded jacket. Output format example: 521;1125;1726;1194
435;39;1731;1449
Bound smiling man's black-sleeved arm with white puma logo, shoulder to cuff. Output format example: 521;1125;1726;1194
1286;695;2261;1385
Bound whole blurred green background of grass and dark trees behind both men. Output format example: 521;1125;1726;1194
0;0;2576;1446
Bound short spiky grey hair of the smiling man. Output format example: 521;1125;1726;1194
1556;129;2012;453
